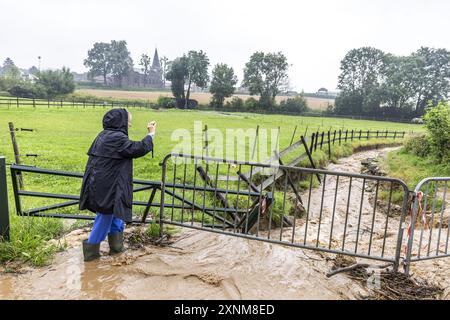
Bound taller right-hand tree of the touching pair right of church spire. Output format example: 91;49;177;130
184;50;209;108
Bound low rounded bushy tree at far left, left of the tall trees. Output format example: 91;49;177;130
35;67;75;98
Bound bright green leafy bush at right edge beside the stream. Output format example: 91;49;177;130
424;102;450;161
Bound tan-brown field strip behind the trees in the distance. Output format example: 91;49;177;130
76;89;334;110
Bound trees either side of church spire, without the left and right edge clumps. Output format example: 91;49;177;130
84;40;307;112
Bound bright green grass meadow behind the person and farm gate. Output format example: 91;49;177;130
0;105;423;265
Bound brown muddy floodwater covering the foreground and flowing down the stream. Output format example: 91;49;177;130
0;148;450;299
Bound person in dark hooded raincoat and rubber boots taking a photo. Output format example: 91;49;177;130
80;109;156;261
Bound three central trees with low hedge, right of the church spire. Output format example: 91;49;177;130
166;50;308;113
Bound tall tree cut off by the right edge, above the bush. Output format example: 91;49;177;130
412;47;450;115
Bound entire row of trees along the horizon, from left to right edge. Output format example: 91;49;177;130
0;40;450;118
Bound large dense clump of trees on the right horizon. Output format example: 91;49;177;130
333;47;450;118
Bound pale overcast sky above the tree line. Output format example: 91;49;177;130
0;0;450;92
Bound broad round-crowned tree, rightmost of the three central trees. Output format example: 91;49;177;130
242;52;289;107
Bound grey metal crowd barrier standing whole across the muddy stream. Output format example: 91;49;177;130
159;154;409;270
